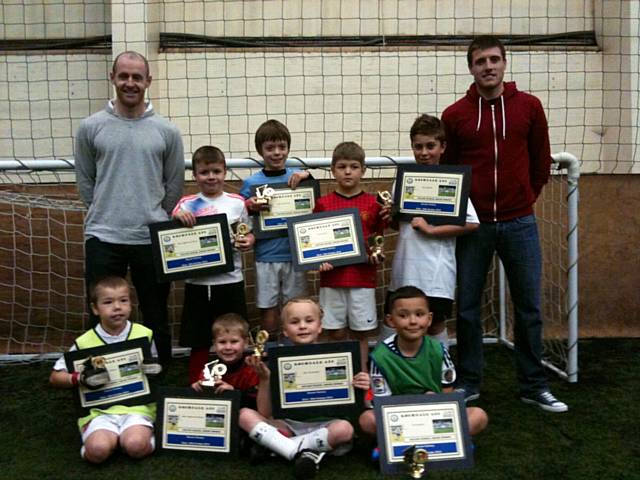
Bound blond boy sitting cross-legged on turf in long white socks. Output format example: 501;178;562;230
239;298;370;479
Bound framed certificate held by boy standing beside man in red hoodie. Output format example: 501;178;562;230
393;165;471;225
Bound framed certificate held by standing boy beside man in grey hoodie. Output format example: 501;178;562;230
149;214;234;282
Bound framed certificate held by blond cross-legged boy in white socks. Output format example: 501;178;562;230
269;342;364;420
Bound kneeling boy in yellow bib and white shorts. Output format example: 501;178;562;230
49;277;160;463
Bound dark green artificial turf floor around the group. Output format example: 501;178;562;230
0;339;640;480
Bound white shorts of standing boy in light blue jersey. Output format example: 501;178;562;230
256;262;307;308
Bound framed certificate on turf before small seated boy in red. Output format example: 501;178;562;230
156;388;240;455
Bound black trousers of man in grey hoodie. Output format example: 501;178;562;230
84;238;171;366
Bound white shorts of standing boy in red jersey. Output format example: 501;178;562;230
318;287;378;332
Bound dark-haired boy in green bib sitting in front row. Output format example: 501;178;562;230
360;286;489;446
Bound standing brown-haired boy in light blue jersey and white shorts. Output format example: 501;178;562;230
240;120;310;336
